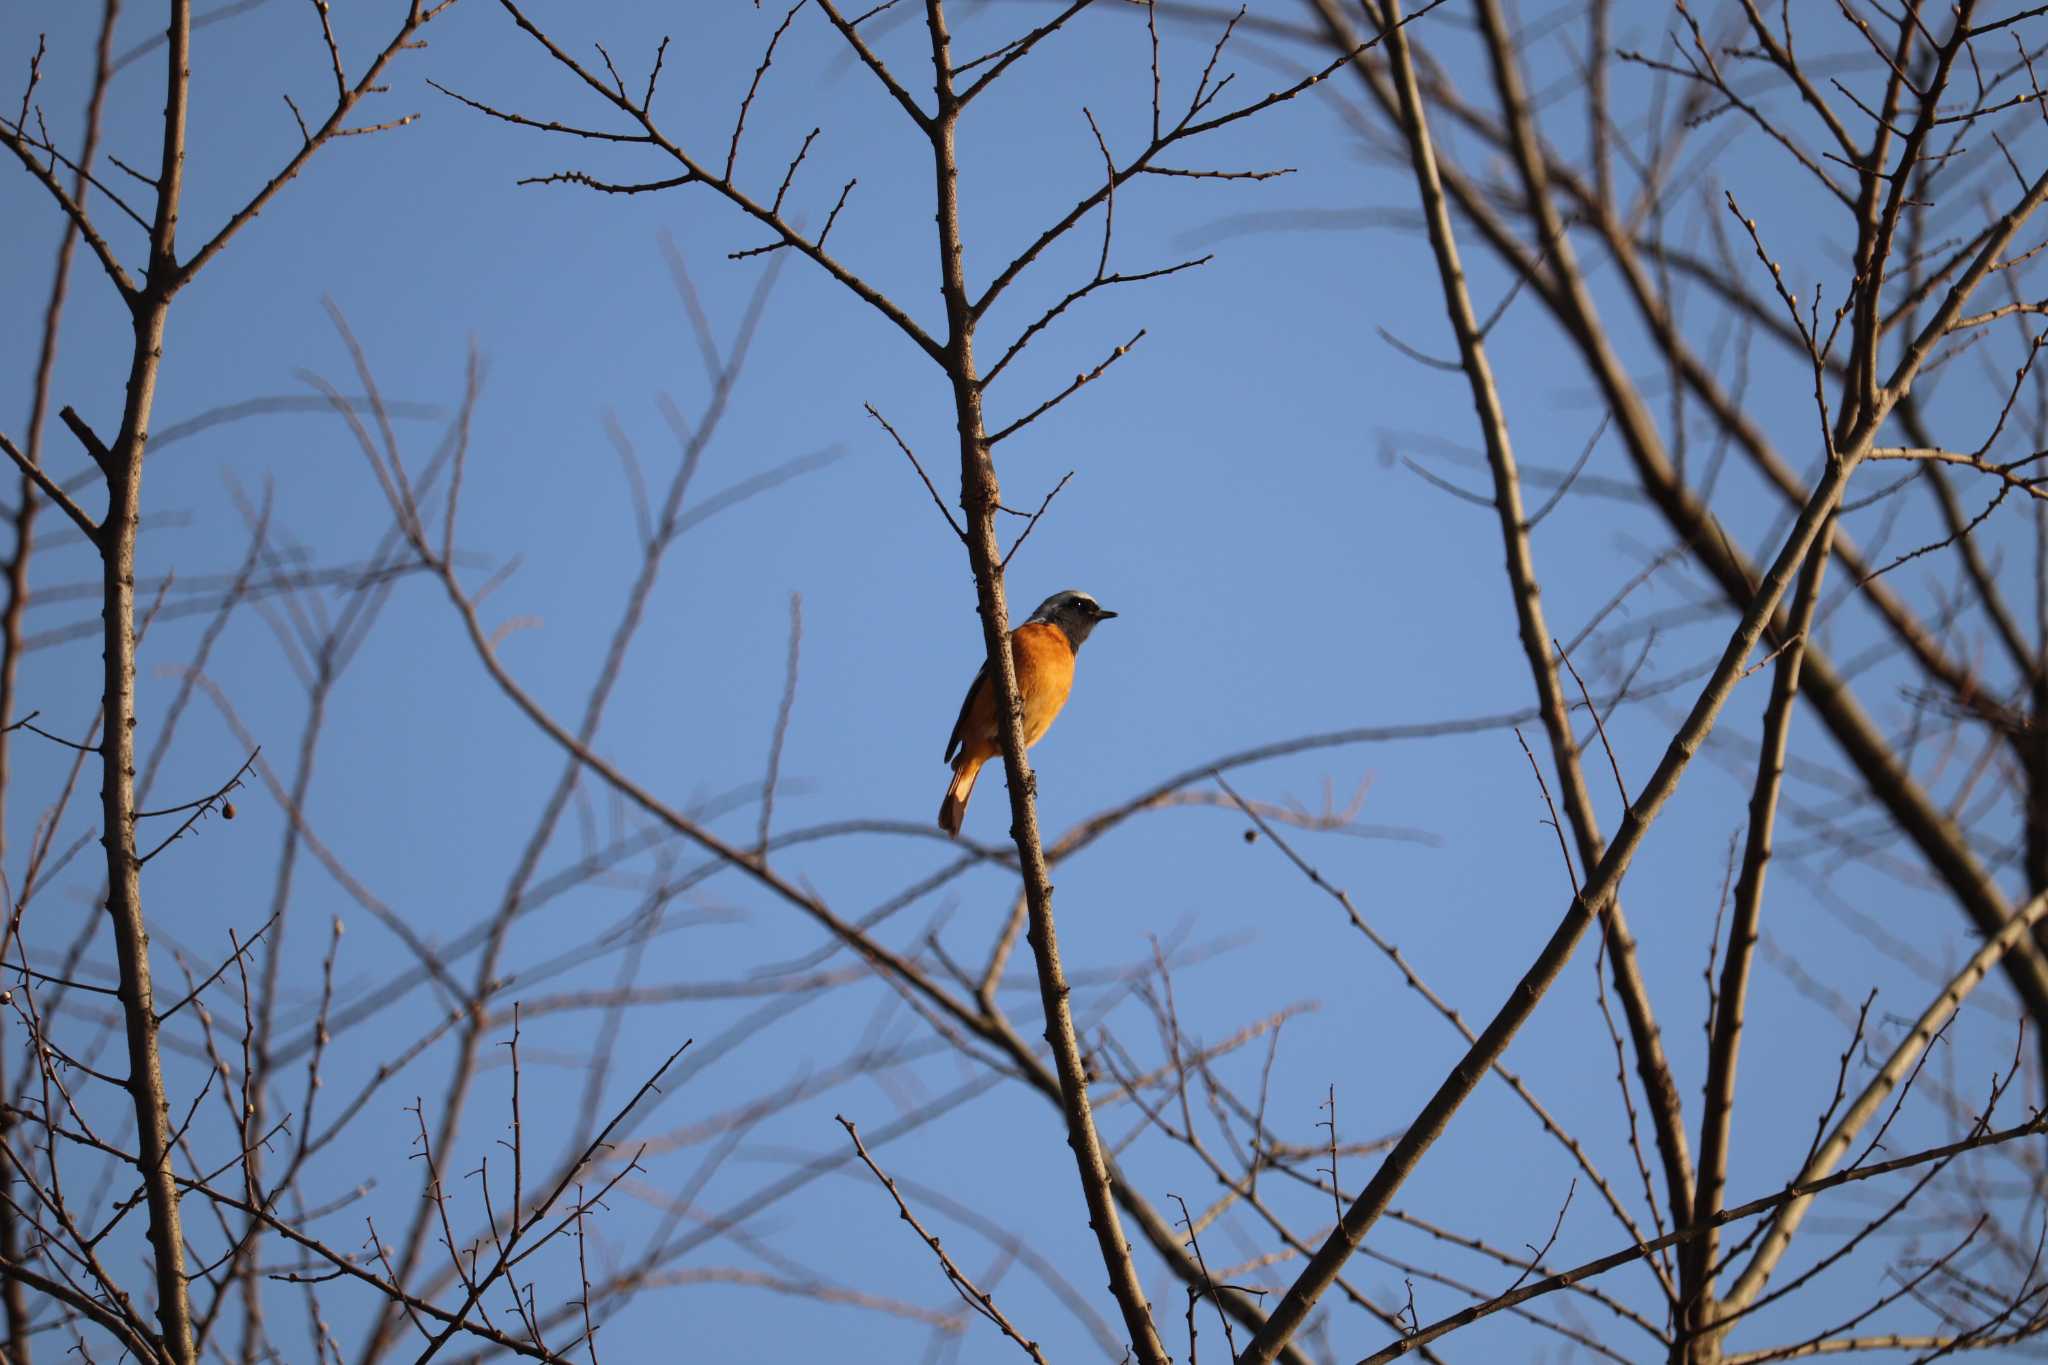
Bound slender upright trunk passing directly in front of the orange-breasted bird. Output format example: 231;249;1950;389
926;0;1169;1365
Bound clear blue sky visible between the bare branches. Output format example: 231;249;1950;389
0;0;2025;1361
